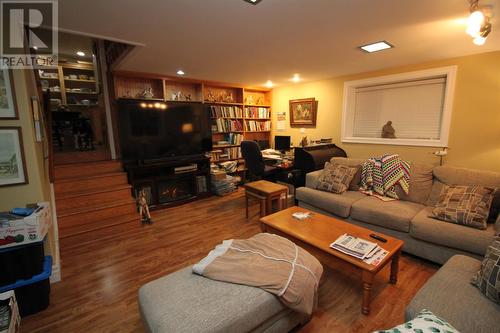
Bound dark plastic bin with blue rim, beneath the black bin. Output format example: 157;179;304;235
0;256;52;317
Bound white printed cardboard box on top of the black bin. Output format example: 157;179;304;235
0;202;52;249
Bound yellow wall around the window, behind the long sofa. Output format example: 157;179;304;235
272;52;500;172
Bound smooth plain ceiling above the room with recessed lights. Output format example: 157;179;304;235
59;0;500;86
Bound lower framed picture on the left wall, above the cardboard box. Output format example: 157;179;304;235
0;127;28;186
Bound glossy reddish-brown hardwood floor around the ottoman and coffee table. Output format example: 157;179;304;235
21;190;437;333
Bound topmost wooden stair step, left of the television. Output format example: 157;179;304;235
54;160;123;181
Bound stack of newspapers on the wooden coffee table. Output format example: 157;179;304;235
330;234;388;266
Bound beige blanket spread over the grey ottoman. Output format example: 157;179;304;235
193;233;323;316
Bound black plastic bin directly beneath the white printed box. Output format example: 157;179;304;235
0;242;45;286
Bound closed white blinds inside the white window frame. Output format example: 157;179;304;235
352;76;446;140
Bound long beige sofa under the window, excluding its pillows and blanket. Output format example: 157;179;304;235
296;157;500;264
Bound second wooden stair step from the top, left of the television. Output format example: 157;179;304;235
54;172;128;193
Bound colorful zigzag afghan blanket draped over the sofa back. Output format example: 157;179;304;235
361;154;410;199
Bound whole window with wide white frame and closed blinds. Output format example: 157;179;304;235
342;67;456;147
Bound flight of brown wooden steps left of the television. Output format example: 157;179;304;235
54;160;139;238
